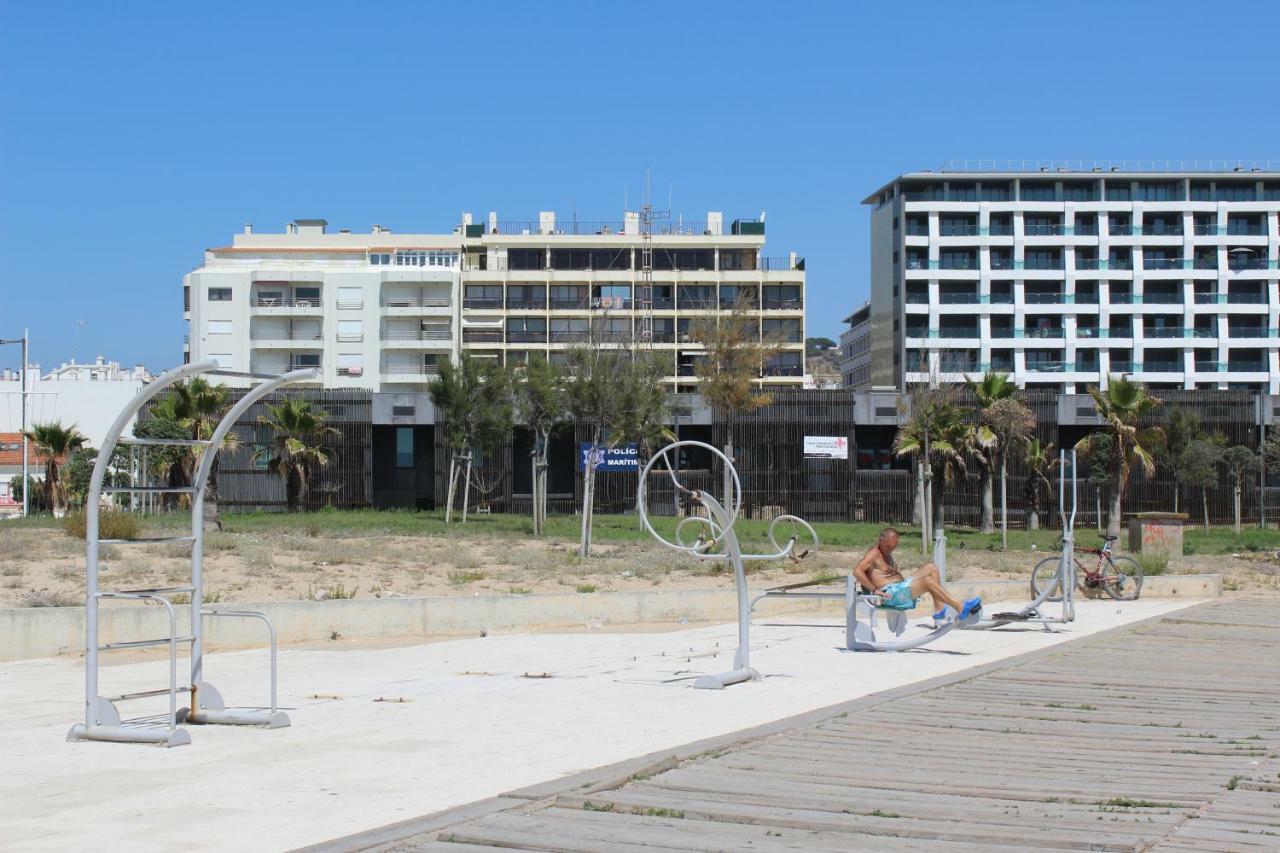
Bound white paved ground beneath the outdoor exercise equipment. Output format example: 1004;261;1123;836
0;591;1194;850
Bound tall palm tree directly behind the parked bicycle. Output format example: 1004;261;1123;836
1075;377;1165;537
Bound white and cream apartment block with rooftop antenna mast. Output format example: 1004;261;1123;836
183;213;805;392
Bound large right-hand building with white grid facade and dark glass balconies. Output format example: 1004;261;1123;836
864;163;1280;394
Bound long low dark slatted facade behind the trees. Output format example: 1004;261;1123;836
194;389;1280;526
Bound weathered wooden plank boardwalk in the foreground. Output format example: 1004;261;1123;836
320;598;1280;853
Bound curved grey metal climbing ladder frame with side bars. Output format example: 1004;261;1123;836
67;360;319;747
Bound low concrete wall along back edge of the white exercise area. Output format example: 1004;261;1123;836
0;575;1222;661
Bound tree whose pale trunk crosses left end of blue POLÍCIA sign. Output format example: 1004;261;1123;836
564;345;671;557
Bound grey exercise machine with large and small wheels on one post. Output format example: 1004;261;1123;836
636;441;818;690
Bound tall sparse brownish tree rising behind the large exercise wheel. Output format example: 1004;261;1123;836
689;297;782;494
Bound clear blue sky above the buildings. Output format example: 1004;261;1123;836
0;0;1280;369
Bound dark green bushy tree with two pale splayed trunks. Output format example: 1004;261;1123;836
426;352;515;524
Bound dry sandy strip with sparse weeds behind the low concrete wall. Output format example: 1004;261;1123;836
0;517;1280;607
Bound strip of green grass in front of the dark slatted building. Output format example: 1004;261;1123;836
5;510;1280;556
